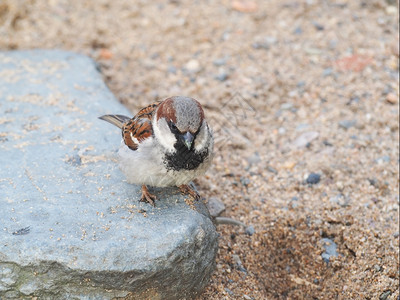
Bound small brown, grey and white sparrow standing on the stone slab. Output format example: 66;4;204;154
99;96;214;206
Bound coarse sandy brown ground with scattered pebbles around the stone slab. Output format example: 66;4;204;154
0;0;399;300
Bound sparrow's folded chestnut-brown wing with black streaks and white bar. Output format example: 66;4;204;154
122;102;161;150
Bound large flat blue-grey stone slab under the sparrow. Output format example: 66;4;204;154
0;50;218;299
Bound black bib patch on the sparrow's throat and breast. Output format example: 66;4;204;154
164;140;208;171
